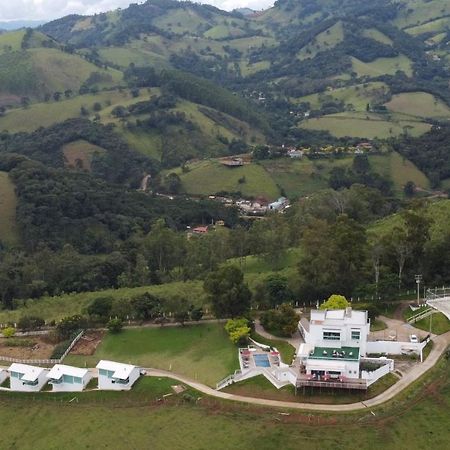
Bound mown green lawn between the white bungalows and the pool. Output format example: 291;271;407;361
65;323;239;387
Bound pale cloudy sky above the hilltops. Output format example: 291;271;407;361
0;0;274;21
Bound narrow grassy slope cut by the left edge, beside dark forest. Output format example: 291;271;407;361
0;172;19;245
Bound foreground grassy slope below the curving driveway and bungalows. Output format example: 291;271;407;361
0;359;450;450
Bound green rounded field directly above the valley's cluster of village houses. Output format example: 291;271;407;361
179;160;280;200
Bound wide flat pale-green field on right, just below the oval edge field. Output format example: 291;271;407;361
300;112;431;139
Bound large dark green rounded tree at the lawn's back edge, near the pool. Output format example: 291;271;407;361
203;266;252;318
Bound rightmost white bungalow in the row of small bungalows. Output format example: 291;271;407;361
97;361;141;391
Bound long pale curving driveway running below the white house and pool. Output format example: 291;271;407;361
146;332;450;412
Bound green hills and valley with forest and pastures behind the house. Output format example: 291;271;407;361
0;0;450;308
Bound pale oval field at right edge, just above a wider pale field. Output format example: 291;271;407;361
385;92;450;118
